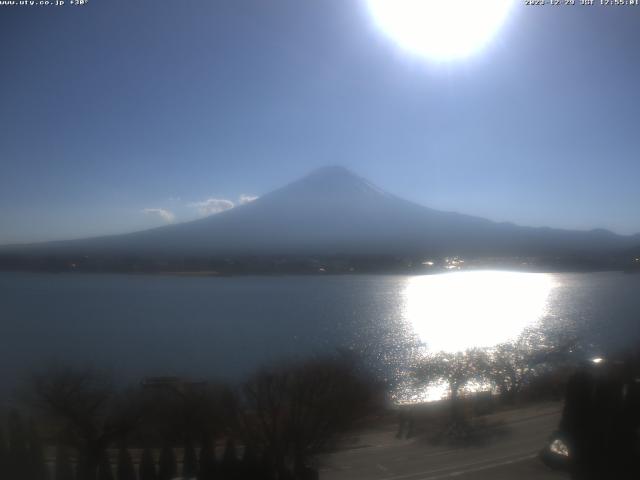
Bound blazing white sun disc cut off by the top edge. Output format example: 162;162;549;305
366;0;513;61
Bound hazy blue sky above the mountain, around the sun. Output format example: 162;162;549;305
0;0;640;243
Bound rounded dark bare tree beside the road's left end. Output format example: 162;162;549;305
240;357;373;476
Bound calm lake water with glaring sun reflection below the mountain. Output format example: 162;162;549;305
0;272;640;396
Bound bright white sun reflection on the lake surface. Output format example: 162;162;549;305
403;271;554;352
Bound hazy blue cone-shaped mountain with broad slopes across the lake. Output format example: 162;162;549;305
1;167;640;256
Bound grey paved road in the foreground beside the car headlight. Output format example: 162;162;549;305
320;404;567;480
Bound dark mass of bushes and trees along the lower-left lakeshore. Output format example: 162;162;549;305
0;350;373;480
